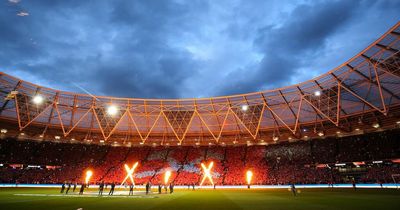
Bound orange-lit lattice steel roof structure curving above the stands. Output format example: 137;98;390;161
0;22;400;145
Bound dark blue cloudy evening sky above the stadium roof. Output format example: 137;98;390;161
0;0;400;98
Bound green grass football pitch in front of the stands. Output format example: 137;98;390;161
0;188;400;210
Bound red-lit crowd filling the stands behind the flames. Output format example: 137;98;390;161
0;130;400;186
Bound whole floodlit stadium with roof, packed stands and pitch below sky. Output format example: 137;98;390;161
0;0;400;209
